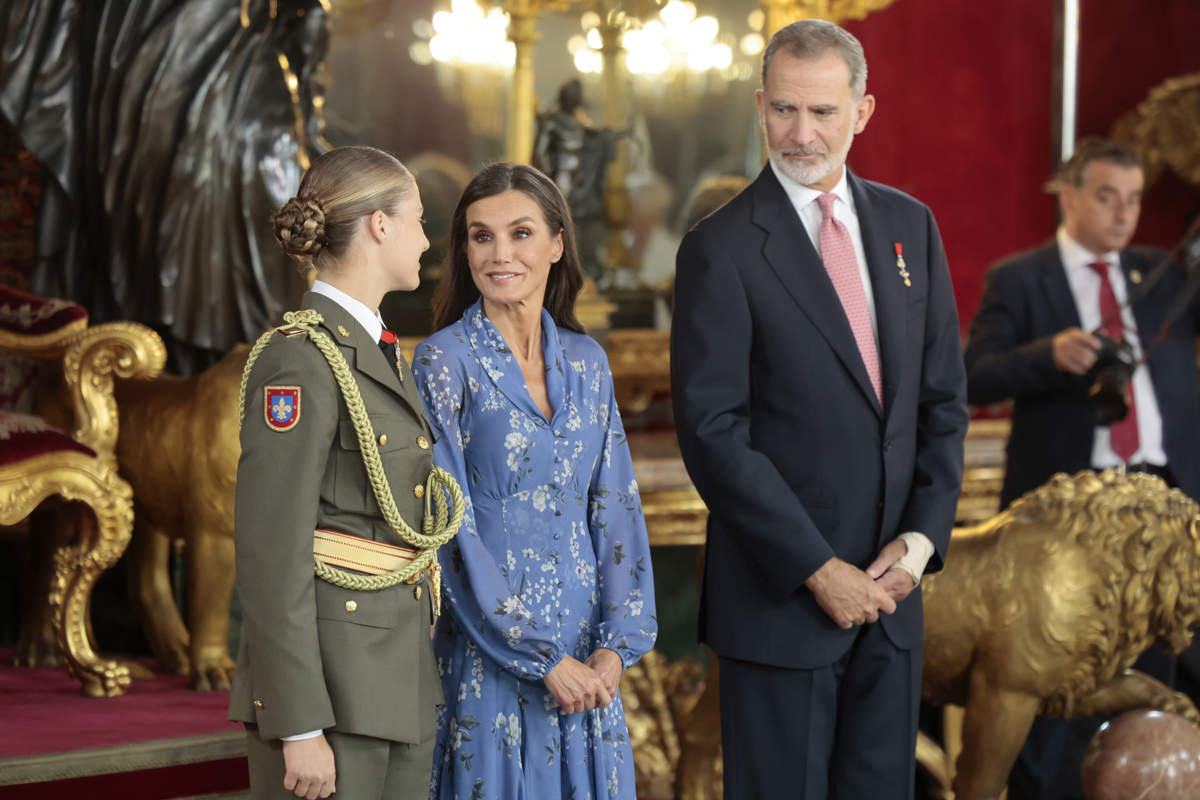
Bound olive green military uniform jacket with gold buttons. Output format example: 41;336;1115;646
228;291;442;744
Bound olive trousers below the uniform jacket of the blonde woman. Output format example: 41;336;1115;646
246;724;436;800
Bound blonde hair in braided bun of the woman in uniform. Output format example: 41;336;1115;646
271;145;416;270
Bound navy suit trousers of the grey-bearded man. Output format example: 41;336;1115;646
720;624;920;800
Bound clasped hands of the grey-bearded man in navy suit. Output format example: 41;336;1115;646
805;539;916;630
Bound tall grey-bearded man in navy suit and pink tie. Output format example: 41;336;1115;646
671;19;967;800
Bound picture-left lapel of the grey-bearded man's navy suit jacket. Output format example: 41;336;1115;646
750;164;880;413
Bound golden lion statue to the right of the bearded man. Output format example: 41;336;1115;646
922;470;1200;800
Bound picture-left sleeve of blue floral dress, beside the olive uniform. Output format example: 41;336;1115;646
413;345;564;680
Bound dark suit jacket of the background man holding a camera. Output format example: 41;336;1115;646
965;240;1200;506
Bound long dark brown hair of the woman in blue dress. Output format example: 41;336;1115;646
433;161;584;333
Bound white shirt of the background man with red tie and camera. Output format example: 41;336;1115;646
1057;228;1166;469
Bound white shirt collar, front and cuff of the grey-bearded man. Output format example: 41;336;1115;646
768;162;934;583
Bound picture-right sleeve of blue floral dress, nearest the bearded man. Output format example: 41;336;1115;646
588;363;659;669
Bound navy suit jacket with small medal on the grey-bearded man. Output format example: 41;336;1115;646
671;166;967;668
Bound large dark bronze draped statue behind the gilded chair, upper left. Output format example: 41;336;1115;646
0;0;328;373
